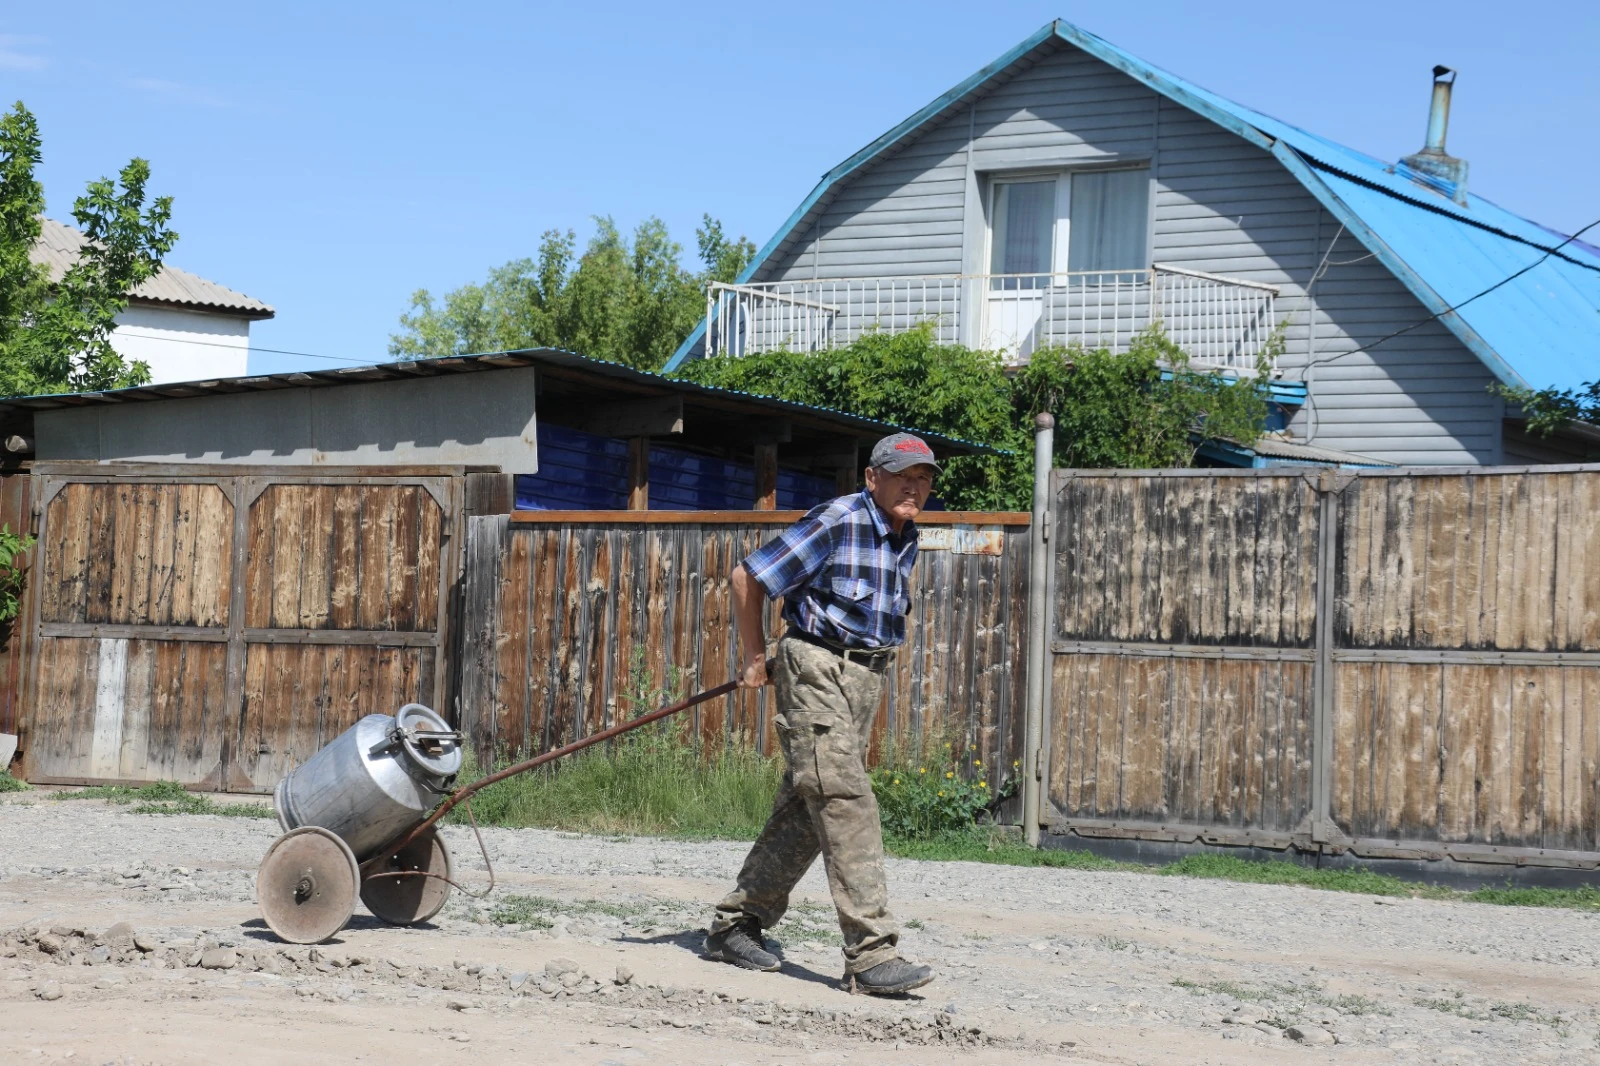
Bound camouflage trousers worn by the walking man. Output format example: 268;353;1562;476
710;637;899;973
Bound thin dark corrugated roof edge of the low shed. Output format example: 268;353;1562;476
0;347;1008;455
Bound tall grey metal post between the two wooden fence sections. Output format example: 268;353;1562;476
1022;411;1056;848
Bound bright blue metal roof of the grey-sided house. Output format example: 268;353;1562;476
667;21;1600;387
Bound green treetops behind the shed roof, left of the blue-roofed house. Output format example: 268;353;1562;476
389;214;755;370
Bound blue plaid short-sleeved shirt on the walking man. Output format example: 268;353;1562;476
744;491;917;648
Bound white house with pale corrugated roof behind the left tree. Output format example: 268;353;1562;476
29;218;274;384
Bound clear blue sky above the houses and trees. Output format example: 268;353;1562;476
0;0;1600;373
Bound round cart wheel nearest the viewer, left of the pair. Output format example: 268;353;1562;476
256;826;362;944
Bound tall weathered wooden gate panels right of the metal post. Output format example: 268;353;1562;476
1043;467;1600;869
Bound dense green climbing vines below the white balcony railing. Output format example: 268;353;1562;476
680;325;1282;511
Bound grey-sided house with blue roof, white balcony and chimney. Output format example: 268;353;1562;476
669;21;1600;464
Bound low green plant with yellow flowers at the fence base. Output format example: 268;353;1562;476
872;743;1014;840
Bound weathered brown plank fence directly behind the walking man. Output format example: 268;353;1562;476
459;511;1027;779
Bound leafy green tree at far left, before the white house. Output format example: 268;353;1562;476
0;101;178;395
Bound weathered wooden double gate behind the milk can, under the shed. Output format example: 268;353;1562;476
26;464;462;792
